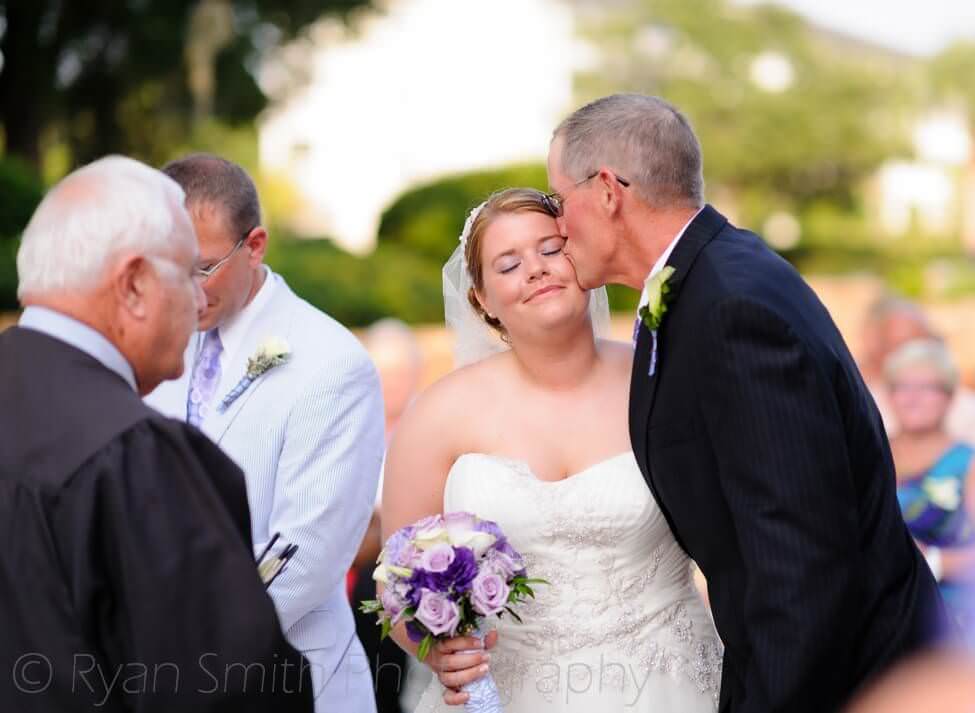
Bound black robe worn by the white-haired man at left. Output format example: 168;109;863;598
0;327;313;713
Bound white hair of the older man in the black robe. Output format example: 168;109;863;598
17;156;196;300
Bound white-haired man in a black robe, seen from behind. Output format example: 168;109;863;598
0;157;312;713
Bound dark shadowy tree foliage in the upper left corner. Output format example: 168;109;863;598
0;0;368;167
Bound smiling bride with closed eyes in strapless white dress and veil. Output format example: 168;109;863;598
382;188;722;713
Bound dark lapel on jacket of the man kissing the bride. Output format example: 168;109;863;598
630;205;728;478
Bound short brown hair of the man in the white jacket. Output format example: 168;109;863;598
162;153;261;237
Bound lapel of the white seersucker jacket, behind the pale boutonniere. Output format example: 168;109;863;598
201;274;293;443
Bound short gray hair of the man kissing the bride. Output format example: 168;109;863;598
554;94;704;208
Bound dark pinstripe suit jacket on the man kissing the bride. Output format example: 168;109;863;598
630;206;944;713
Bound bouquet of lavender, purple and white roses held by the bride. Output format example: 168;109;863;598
361;512;546;713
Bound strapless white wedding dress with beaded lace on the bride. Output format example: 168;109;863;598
416;452;722;713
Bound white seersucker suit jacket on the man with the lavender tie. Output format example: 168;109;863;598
146;271;384;680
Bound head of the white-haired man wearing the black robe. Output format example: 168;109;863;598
17;156;205;393
